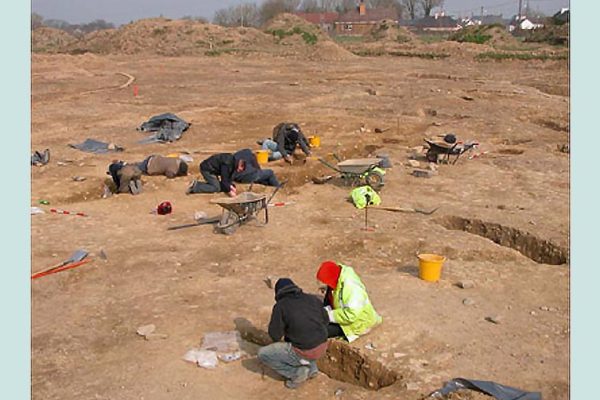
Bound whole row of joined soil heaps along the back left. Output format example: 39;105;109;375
33;14;354;61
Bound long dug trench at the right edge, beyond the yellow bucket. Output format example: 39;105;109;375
436;216;569;265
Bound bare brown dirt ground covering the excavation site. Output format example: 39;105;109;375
31;36;570;400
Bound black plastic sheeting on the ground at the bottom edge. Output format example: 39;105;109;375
429;378;542;400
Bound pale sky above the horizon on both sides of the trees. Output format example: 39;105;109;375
31;0;569;25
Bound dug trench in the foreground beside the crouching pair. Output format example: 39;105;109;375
237;324;401;390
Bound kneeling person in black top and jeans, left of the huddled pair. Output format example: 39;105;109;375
186;153;237;197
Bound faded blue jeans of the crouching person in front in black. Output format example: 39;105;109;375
258;342;319;383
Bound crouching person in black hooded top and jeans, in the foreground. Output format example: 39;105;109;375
258;278;329;389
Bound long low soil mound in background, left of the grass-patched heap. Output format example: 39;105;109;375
69;18;273;56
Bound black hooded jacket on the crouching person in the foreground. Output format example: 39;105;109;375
269;285;329;350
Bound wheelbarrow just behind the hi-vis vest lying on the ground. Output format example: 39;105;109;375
313;155;385;190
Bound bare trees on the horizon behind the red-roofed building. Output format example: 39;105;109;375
212;0;444;27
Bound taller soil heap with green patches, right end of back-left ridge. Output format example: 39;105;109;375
265;13;355;61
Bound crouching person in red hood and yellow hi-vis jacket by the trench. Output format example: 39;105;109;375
317;261;382;342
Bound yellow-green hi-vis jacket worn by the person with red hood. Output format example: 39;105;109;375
330;264;382;341
